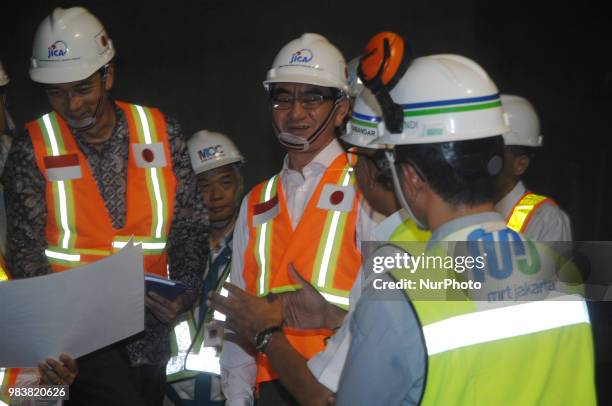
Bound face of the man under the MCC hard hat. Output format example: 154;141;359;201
198;165;242;221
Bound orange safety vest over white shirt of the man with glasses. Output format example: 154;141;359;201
243;154;361;383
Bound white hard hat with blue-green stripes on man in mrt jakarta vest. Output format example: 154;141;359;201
370;54;509;145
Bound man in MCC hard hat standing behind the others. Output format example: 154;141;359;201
166;130;244;406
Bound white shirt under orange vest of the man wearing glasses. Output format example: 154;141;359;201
221;139;375;406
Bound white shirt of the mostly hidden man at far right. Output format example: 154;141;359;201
495;182;572;242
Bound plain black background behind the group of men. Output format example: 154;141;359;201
0;0;612;400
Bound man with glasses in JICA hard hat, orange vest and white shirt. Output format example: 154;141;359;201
221;34;373;405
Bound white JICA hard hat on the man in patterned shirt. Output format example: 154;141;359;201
30;7;115;83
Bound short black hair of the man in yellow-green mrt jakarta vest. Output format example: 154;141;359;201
396;136;503;206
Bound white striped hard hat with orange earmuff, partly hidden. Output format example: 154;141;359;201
341;88;385;149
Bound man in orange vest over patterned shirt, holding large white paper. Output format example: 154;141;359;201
4;7;208;405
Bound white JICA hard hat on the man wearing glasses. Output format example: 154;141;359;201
263;33;348;92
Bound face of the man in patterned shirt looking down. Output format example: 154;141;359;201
45;72;112;122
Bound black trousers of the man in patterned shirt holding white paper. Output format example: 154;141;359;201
65;344;166;406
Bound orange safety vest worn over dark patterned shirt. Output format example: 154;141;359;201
26;102;176;276
